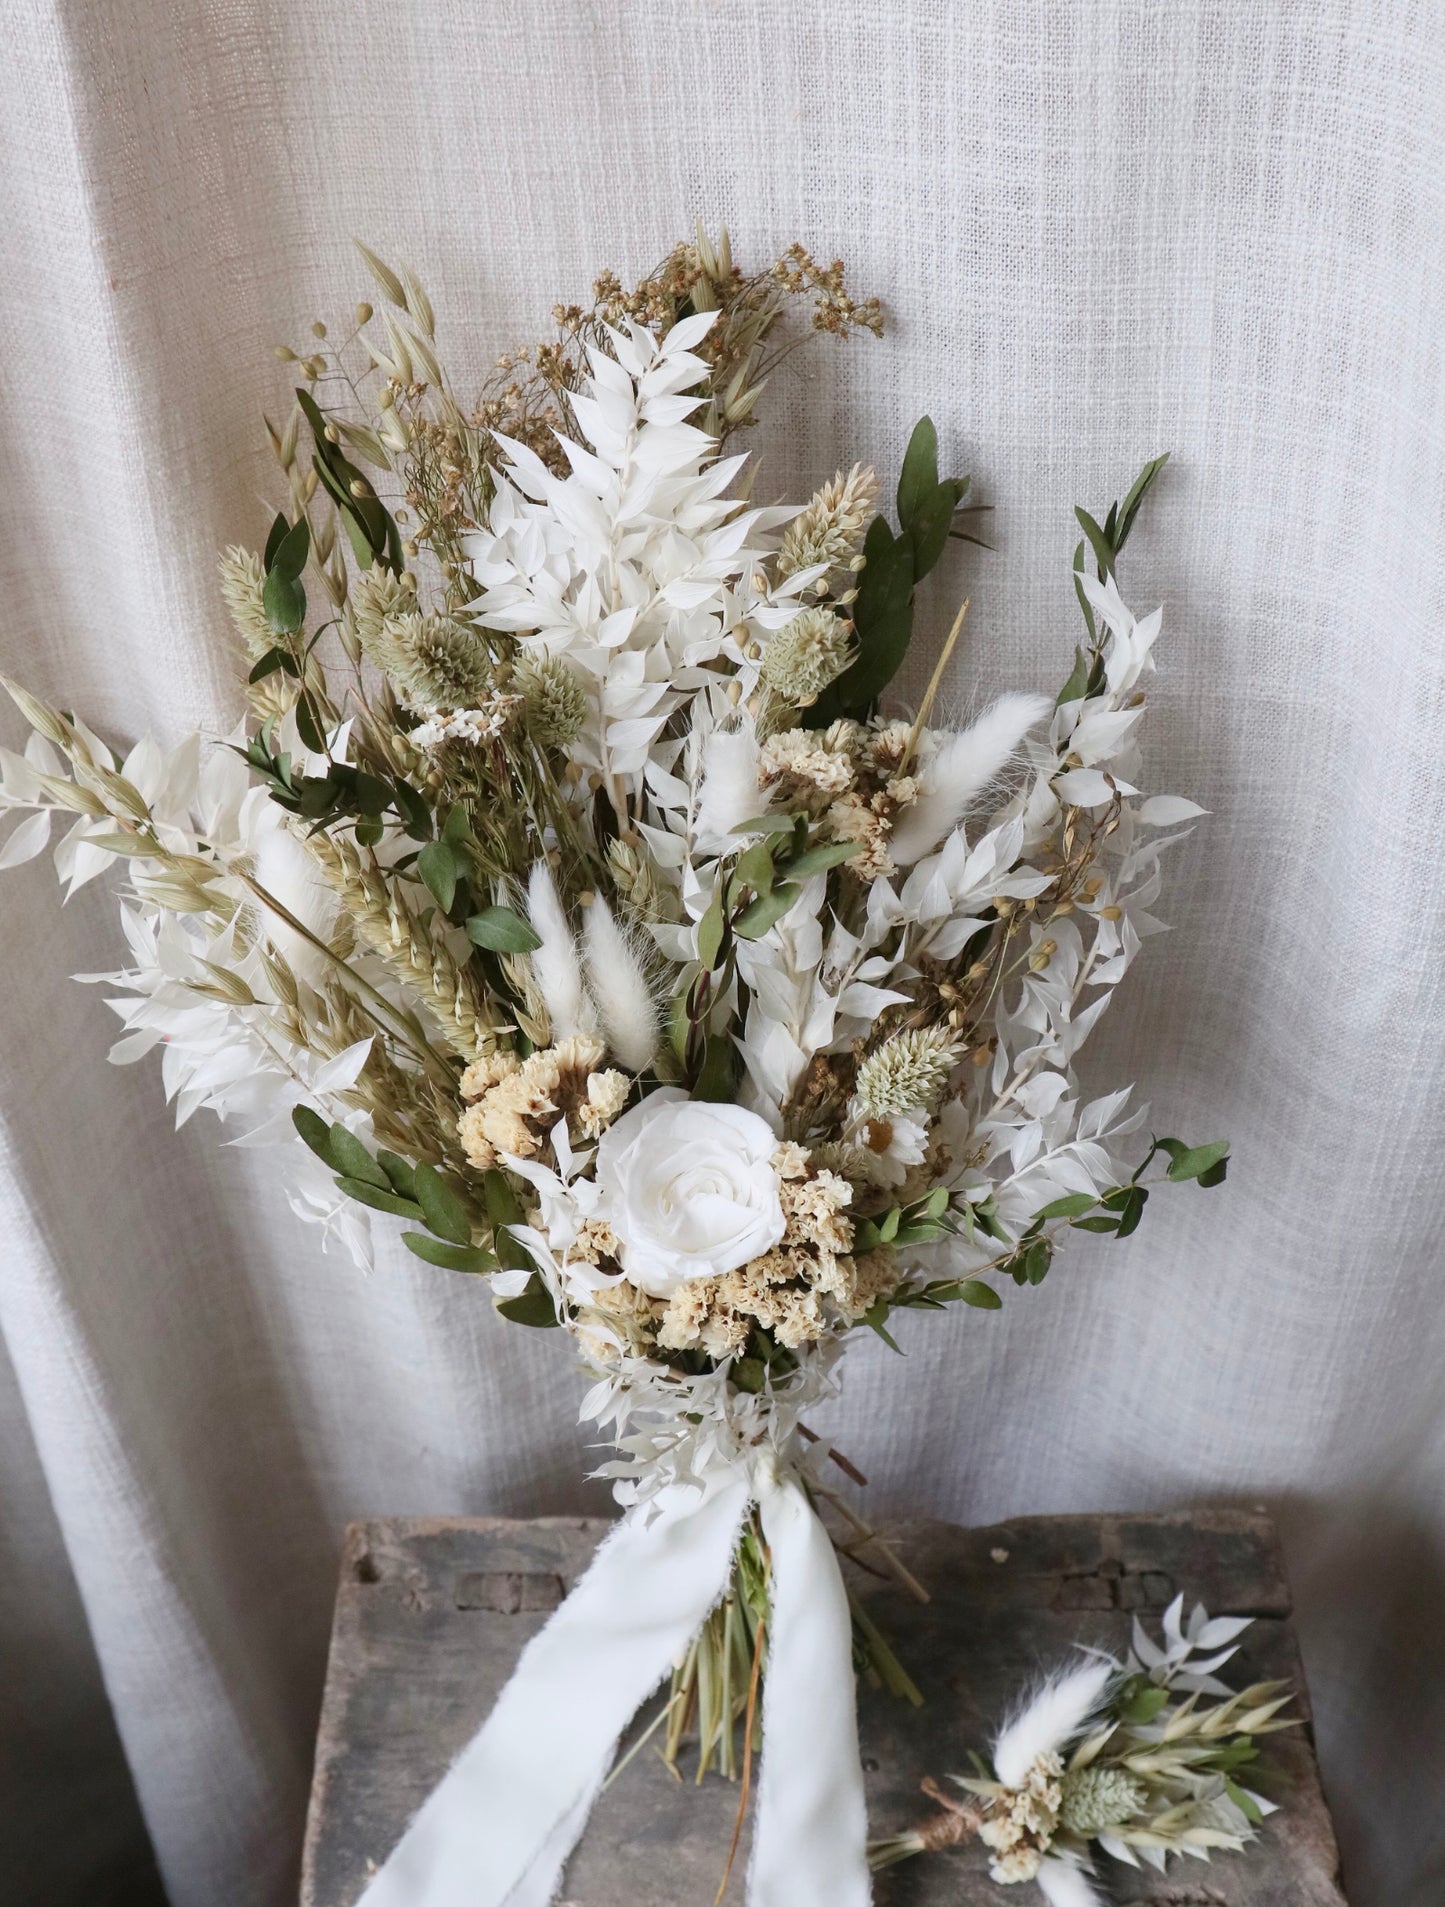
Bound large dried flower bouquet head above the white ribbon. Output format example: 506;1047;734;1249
0;235;1226;1777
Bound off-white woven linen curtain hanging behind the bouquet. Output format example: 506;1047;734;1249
0;0;1445;1907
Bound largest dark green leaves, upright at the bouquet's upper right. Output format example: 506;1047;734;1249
803;418;968;728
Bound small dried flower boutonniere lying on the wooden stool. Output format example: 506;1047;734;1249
869;1596;1298;1907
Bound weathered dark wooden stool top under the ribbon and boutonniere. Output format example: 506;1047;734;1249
301;1510;1344;1907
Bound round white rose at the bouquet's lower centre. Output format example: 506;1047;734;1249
597;1089;785;1299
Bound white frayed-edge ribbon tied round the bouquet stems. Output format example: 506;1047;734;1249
358;1457;871;1907
